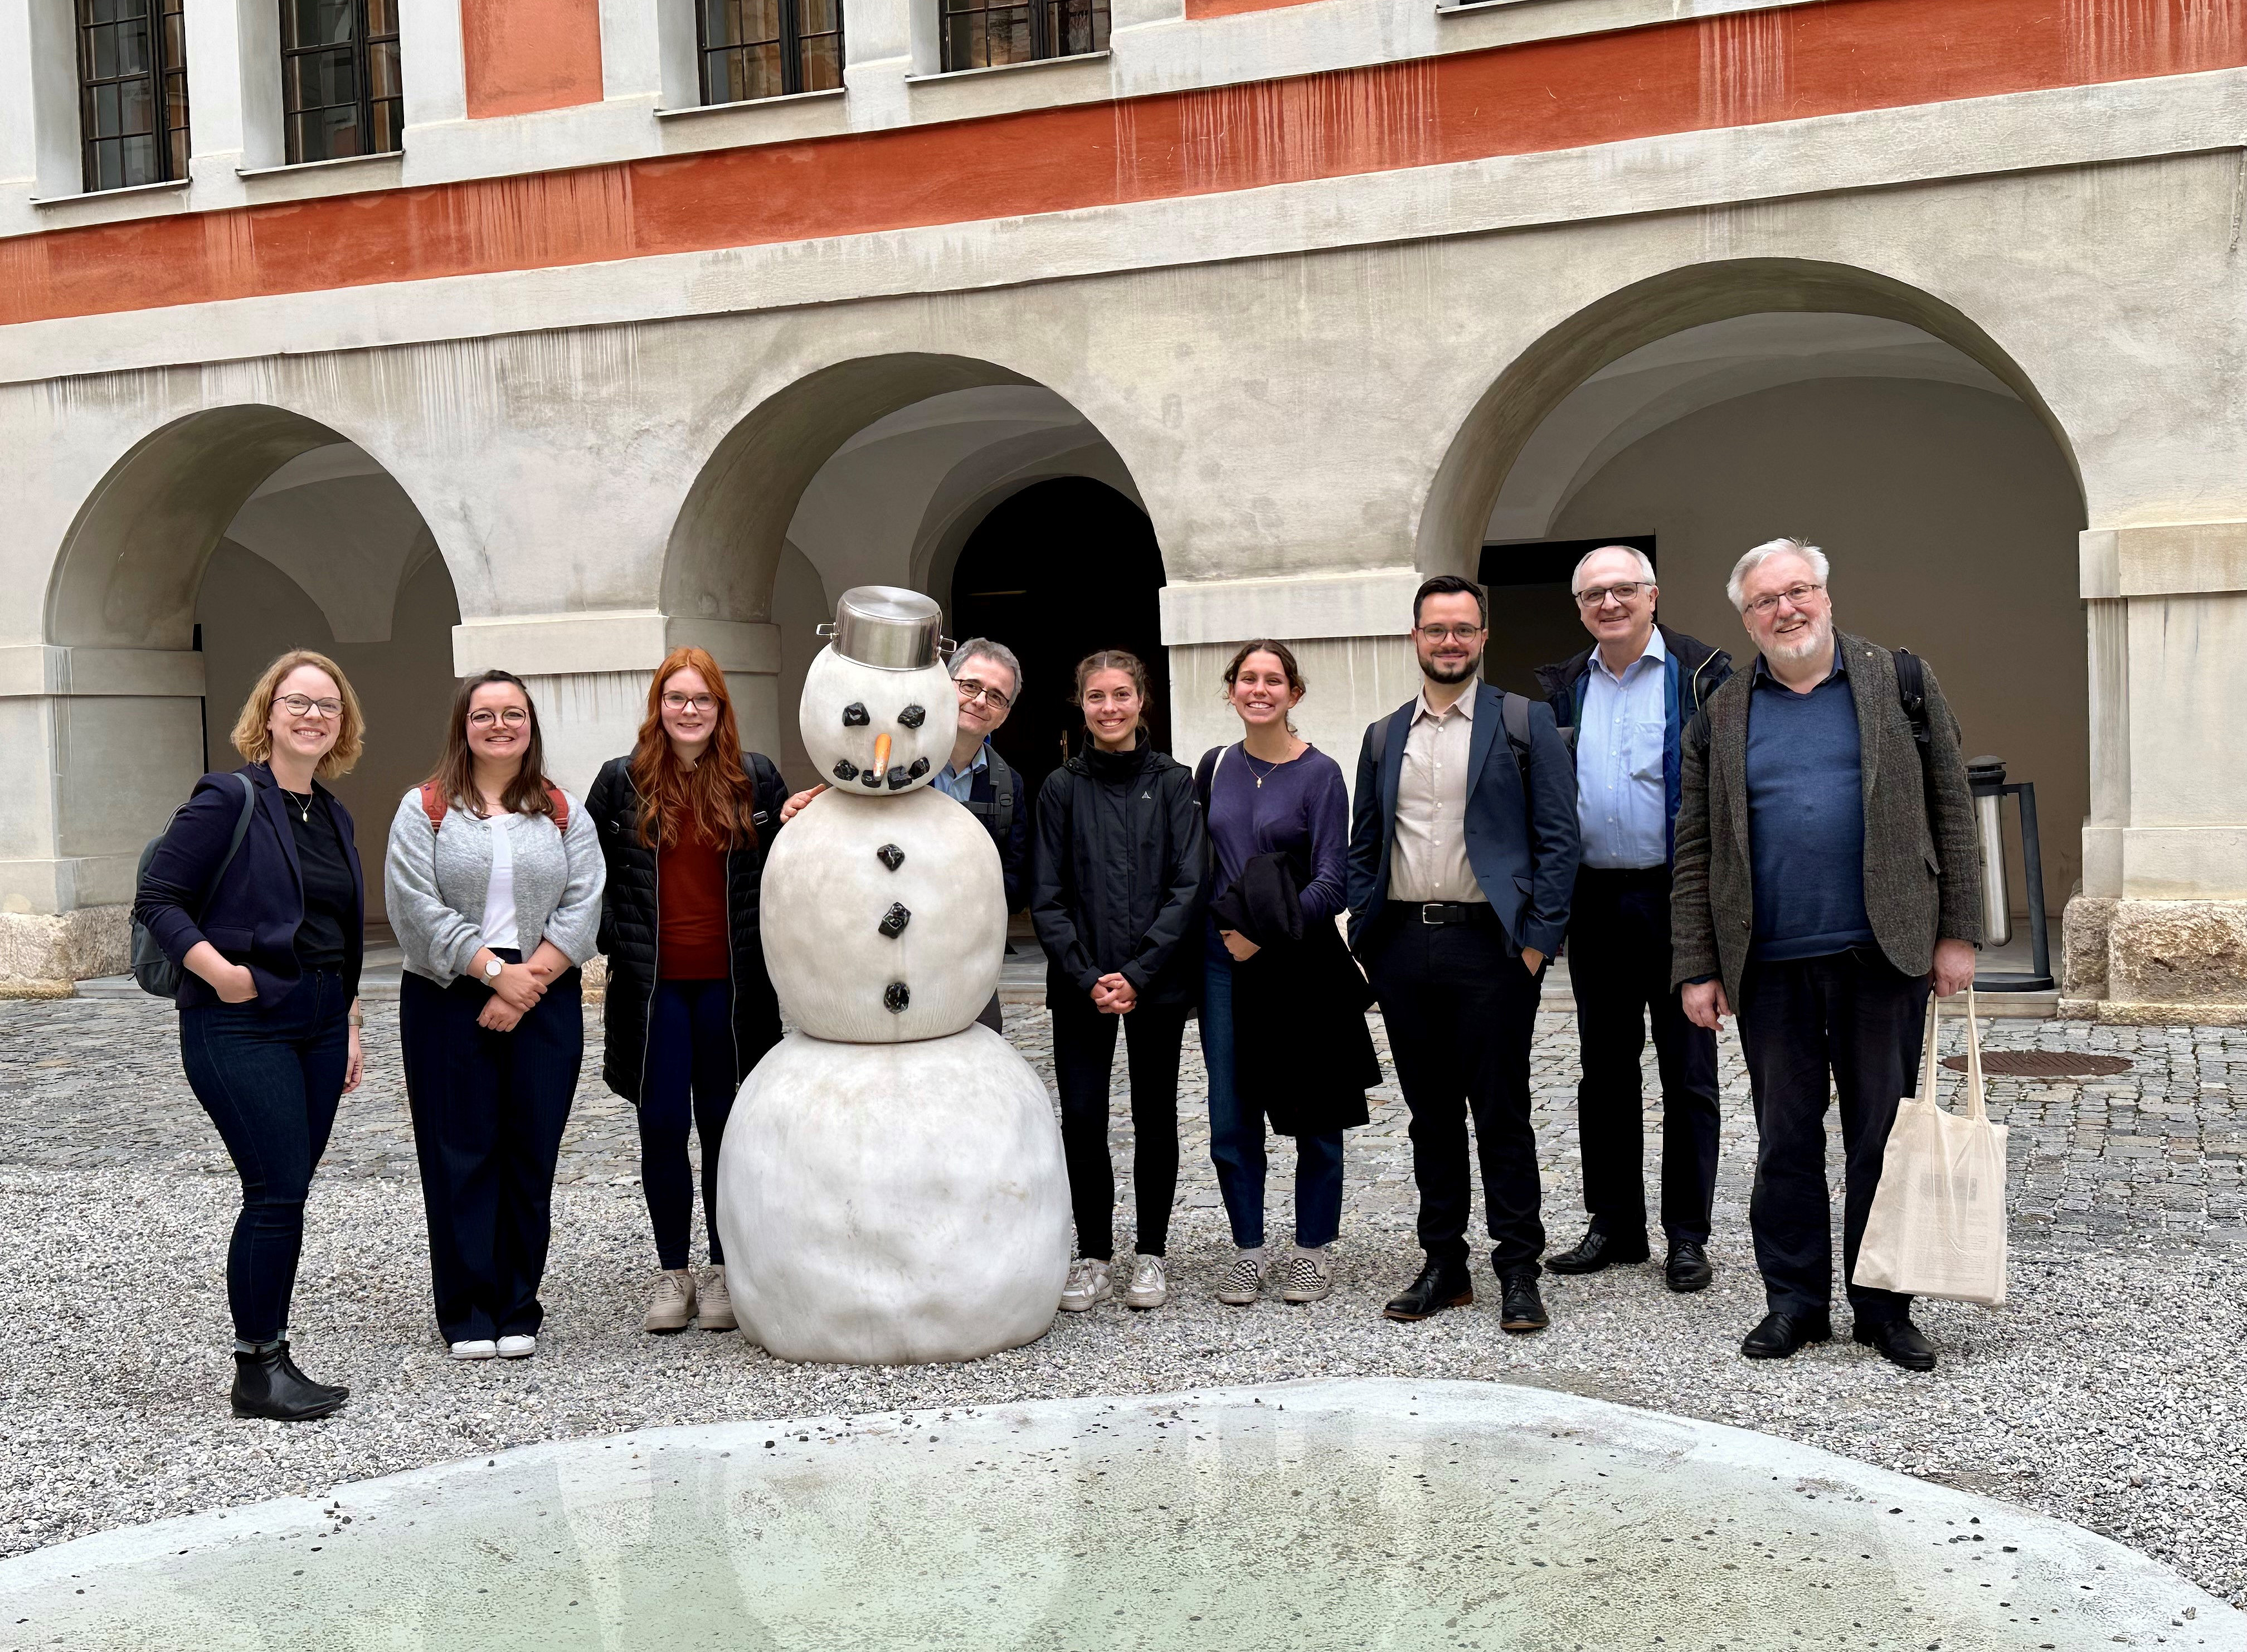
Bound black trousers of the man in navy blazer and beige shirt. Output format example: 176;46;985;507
1364;906;1544;1275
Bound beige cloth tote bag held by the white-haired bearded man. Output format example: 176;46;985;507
1856;987;2005;1308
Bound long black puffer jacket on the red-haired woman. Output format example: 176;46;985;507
584;751;789;1106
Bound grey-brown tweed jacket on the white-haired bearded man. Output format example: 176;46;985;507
1670;631;1982;1009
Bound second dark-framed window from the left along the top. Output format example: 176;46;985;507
281;0;405;166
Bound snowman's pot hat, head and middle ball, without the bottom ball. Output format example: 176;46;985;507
760;584;1006;1043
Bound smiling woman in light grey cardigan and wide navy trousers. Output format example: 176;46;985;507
384;672;605;1360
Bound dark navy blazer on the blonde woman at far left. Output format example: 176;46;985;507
133;762;366;1009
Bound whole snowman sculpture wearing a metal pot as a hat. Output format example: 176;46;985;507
717;584;1069;1364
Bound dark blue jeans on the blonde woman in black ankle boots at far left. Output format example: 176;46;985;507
180;969;351;1342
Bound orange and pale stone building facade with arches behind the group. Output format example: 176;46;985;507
0;0;2247;1021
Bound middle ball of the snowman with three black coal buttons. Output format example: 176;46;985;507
760;786;1006;1043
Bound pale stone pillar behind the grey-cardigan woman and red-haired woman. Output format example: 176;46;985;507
451;609;780;796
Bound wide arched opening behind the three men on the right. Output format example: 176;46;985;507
1422;261;2090;926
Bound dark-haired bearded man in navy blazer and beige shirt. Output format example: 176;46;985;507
1348;573;1577;1330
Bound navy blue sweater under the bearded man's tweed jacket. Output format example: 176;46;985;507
1748;652;1874;964
